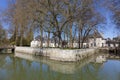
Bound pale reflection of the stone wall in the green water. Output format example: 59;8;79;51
15;53;98;74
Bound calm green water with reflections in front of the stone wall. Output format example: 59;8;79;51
0;54;120;80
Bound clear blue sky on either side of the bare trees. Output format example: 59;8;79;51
0;0;117;38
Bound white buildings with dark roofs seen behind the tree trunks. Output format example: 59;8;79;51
31;32;107;48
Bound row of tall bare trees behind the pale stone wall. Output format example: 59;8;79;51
1;0;119;48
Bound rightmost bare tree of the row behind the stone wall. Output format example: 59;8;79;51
77;0;104;48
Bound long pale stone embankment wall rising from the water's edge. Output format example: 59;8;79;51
15;47;97;61
